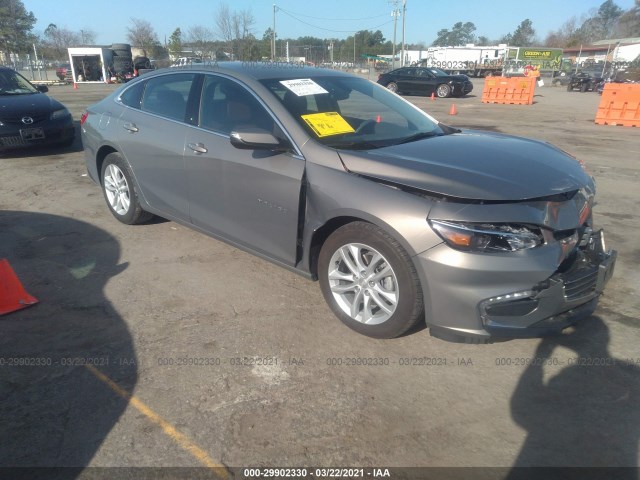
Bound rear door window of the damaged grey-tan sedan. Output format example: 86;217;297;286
142;73;196;122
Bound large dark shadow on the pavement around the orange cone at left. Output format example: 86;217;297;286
0;211;137;472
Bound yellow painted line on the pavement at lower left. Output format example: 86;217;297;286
85;365;229;480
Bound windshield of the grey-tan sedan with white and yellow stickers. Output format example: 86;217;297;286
262;77;445;150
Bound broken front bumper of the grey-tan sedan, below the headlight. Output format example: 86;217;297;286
420;231;617;342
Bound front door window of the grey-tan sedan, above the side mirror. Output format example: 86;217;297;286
199;75;275;134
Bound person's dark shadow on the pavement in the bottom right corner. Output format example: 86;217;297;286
507;316;640;480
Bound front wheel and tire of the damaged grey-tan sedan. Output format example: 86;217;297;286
318;222;424;338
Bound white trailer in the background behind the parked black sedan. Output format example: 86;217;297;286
422;44;507;77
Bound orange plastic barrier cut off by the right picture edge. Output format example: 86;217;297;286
596;83;640;127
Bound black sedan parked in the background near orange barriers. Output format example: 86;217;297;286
378;67;473;98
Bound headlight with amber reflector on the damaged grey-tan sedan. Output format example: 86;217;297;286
429;220;544;252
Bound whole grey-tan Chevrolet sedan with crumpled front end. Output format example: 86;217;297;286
81;62;616;342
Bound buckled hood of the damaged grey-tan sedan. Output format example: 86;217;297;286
340;131;592;201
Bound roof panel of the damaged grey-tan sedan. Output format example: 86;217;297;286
157;61;351;80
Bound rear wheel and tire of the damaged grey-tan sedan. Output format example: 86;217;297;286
100;153;153;225
